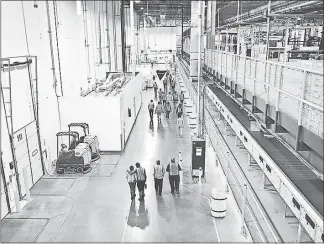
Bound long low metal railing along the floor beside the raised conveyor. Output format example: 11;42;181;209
178;58;282;242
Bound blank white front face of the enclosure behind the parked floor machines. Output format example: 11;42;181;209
55;96;121;152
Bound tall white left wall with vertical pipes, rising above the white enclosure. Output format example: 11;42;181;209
1;1;128;166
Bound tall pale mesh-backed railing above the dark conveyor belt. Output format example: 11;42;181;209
205;49;323;138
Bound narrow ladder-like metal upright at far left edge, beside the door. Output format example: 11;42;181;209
1;58;22;199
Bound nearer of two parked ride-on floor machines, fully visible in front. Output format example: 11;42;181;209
56;131;91;174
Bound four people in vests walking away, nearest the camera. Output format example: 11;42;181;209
126;158;182;202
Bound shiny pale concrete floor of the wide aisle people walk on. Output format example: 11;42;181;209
1;63;251;243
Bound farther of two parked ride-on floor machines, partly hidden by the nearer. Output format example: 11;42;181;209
68;123;100;161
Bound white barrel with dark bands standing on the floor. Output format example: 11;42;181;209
210;188;227;218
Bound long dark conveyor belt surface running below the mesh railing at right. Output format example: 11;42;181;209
209;85;324;217
